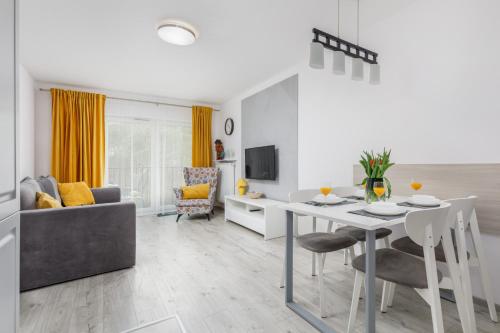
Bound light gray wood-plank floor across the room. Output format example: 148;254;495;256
21;211;500;333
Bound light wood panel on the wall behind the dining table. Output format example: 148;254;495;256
354;164;500;235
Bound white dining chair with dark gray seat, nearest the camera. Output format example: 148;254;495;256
347;203;455;333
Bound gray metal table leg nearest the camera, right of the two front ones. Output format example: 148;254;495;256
365;230;376;333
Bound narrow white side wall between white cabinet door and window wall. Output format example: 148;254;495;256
19;65;35;179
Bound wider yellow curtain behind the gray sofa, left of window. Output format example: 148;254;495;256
50;88;106;187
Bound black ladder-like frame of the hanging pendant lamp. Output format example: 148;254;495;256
312;28;378;64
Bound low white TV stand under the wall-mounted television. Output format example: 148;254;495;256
224;195;286;240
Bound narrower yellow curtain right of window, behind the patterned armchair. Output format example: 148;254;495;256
192;105;213;167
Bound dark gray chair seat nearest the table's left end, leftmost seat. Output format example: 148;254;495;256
297;232;357;253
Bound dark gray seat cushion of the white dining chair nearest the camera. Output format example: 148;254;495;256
352;249;443;289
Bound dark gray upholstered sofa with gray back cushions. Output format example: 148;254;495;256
20;177;136;291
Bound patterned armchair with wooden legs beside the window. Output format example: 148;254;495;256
174;168;219;222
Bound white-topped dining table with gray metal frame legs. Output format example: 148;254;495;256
279;197;419;333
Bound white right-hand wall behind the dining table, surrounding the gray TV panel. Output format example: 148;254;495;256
214;0;500;304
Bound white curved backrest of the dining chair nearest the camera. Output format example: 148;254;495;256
405;203;451;246
